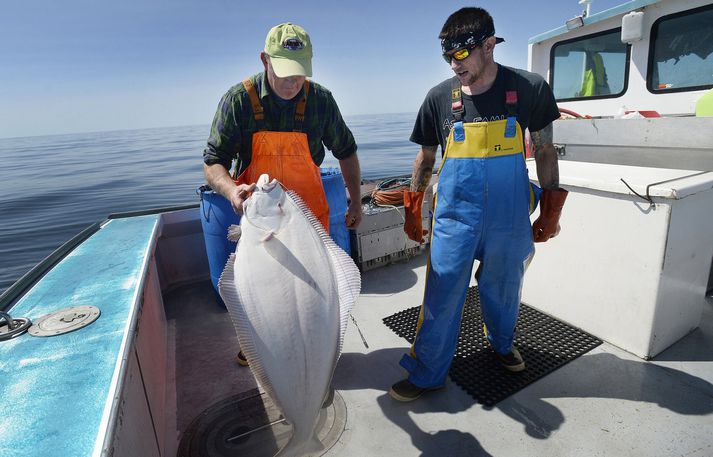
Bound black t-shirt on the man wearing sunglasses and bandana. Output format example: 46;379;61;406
411;64;560;153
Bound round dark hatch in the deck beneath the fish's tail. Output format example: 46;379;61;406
177;389;347;457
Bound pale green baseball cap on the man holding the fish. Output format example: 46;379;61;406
265;22;312;78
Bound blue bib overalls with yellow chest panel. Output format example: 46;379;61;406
401;118;540;387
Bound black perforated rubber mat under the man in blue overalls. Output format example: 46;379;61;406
384;287;602;406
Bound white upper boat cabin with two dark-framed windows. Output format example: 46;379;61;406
528;0;713;117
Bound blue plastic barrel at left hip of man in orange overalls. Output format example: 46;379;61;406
198;186;240;292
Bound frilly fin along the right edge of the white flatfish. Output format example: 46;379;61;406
287;191;361;358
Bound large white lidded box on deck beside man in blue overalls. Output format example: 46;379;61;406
522;160;713;359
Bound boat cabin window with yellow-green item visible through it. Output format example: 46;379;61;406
550;28;630;101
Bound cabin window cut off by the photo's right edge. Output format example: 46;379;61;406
646;6;713;93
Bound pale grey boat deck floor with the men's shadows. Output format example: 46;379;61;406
164;255;713;457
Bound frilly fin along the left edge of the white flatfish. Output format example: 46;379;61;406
218;251;283;411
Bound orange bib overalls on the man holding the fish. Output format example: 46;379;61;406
235;79;329;233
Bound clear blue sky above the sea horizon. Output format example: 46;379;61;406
0;0;623;138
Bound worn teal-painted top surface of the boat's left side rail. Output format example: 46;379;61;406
0;215;158;457
